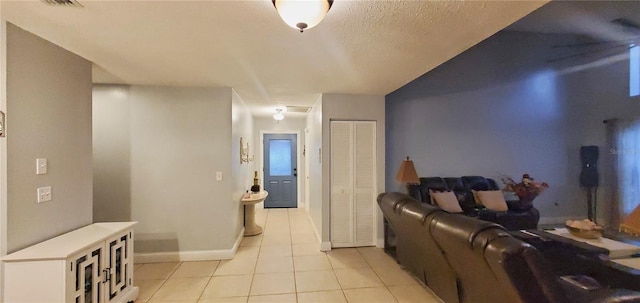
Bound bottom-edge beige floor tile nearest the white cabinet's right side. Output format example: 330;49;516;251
149;278;210;302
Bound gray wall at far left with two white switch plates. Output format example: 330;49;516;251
3;24;92;253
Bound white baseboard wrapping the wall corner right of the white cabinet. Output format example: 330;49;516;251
133;227;244;263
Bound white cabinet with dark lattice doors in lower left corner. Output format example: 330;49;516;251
2;222;138;303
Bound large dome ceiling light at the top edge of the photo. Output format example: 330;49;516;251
271;0;333;33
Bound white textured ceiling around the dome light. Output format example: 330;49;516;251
0;0;547;116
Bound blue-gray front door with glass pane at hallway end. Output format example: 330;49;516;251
264;134;298;208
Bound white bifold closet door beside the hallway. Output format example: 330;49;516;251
330;121;376;247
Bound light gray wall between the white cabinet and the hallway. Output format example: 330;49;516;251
94;86;239;253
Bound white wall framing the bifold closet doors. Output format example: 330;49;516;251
321;94;386;246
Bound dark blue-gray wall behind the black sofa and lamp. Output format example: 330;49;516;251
386;32;640;222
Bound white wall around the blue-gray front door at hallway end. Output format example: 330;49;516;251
251;114;306;207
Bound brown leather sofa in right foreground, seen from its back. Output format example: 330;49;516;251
378;193;640;303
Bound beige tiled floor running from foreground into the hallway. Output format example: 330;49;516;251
134;209;441;303
